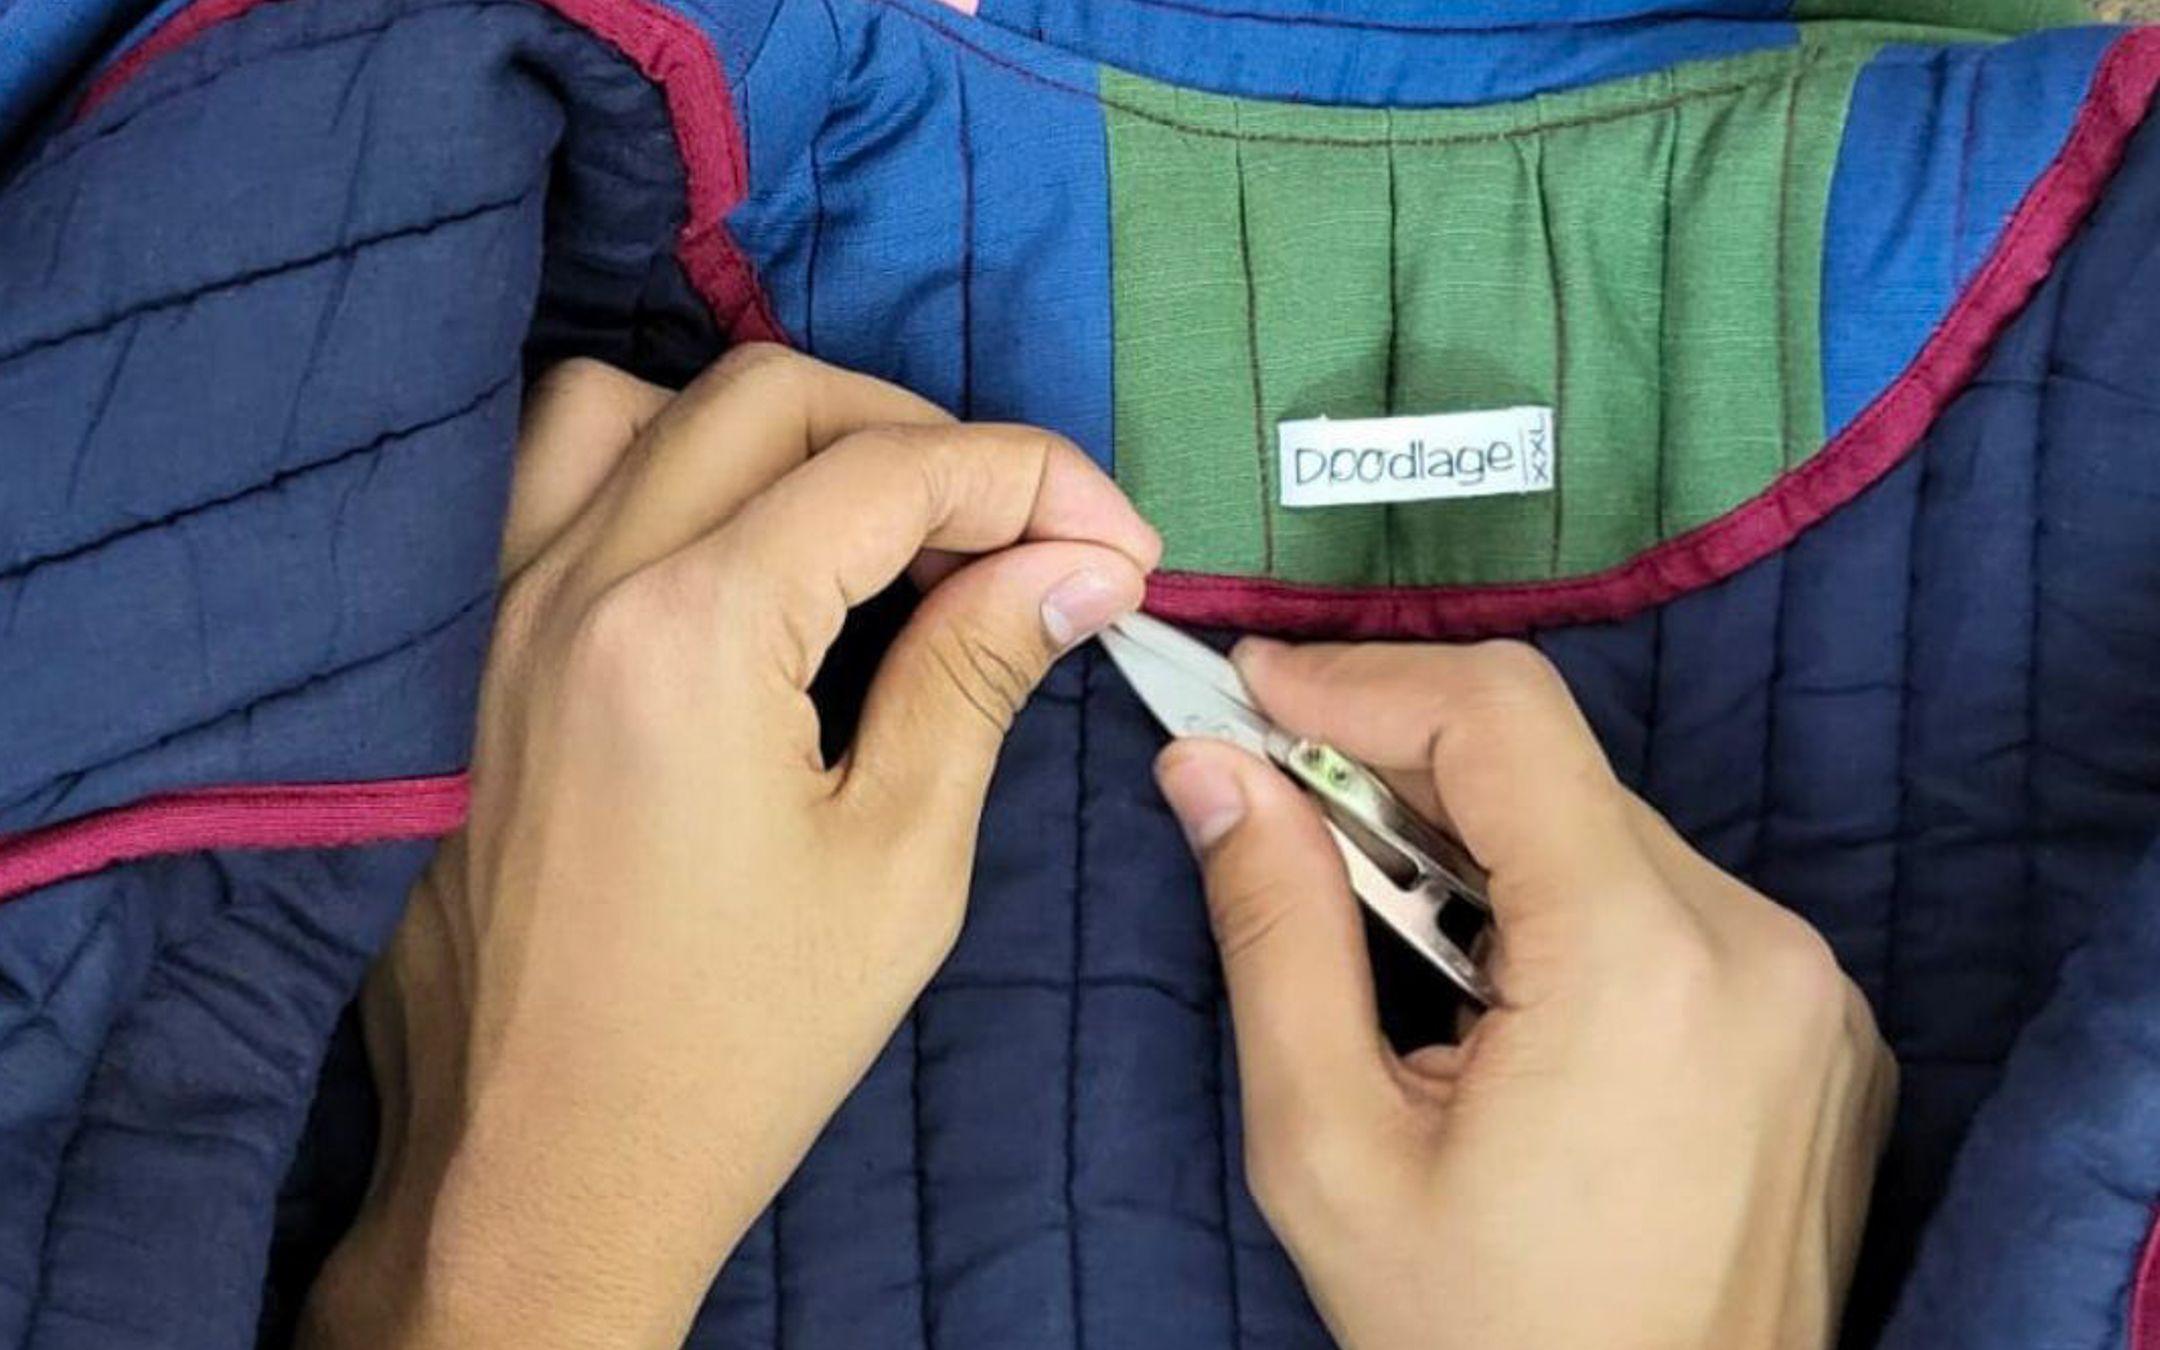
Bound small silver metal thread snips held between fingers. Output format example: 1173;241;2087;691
1099;613;1497;1007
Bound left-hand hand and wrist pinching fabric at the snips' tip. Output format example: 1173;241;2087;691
309;348;1160;1350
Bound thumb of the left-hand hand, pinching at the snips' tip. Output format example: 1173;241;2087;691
842;542;1145;827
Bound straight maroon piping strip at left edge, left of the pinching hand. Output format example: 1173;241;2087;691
0;773;471;901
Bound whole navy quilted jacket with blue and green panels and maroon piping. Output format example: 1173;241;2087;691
0;0;2160;1350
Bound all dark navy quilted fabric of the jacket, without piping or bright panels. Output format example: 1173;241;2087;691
0;0;2160;1350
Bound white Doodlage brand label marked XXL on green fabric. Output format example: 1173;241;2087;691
1277;408;1560;505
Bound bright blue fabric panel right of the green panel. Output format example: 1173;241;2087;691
1823;28;2119;434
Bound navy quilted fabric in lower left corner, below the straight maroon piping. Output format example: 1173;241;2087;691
0;845;430;1350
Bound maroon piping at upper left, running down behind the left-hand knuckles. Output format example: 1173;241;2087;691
76;0;786;341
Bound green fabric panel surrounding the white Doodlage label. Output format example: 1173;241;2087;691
1102;41;1875;585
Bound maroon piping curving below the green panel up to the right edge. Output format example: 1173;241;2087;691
1147;28;2160;639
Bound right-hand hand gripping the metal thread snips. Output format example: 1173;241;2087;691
1158;642;1896;1350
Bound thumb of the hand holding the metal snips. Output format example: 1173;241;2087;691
1156;741;1393;1158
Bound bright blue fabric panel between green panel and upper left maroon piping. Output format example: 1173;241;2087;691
732;2;1110;464
